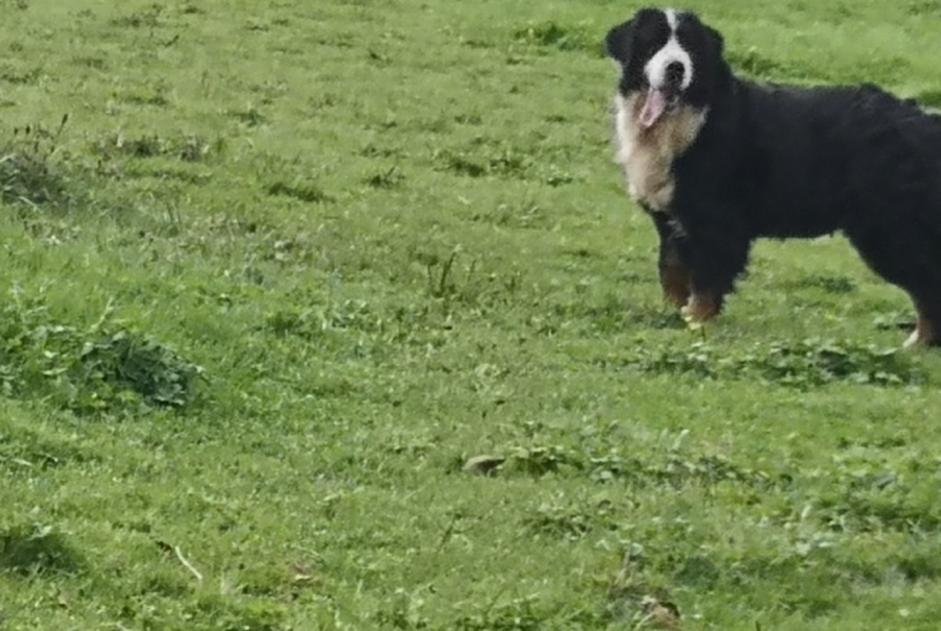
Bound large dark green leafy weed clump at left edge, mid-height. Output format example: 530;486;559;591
0;299;202;414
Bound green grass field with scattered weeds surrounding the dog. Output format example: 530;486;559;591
0;0;941;631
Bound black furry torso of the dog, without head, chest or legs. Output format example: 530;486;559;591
674;81;941;237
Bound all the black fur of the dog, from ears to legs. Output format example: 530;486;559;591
607;9;941;343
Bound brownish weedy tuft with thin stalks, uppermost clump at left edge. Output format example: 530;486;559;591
0;116;75;208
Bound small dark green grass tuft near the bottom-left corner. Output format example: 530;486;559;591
0;525;84;576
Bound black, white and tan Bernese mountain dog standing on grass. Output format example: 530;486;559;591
607;9;941;346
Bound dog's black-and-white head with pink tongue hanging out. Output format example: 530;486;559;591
606;9;730;129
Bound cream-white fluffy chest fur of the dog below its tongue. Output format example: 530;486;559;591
615;94;706;212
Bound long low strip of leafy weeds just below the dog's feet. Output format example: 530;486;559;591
625;339;924;388
